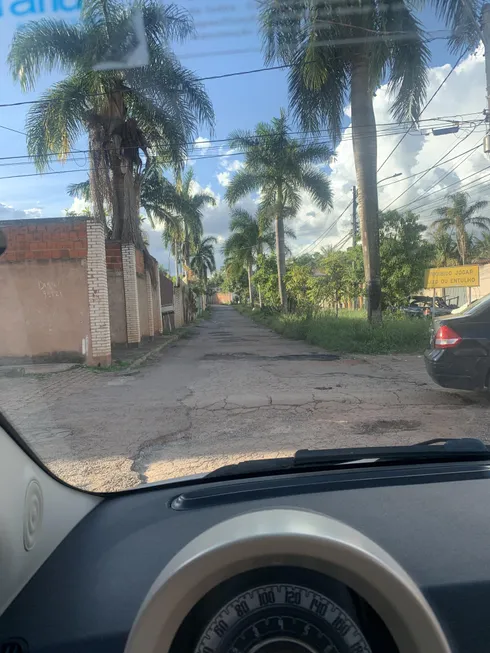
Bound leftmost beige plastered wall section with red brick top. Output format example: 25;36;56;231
0;218;91;361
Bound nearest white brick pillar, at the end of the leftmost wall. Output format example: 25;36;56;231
87;220;111;365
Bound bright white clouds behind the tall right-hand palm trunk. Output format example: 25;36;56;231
293;47;490;251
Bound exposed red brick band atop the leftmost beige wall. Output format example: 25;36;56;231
1;218;87;263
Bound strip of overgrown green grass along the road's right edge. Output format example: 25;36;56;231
236;306;430;354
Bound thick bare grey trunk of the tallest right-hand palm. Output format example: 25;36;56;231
351;54;381;322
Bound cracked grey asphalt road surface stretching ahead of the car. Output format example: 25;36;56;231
0;306;490;491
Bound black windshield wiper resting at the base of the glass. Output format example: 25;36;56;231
206;438;490;478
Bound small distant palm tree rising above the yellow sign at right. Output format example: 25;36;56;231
434;192;490;265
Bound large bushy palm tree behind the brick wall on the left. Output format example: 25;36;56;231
8;0;214;244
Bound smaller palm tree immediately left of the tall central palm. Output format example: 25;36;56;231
223;209;274;305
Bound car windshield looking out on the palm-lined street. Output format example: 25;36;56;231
0;0;490;491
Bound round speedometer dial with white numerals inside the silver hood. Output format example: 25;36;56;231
195;583;371;653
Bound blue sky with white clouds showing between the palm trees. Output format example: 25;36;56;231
0;0;490;268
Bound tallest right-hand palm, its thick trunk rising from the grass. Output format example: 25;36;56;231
260;0;480;320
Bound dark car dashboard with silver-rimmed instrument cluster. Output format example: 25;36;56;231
0;462;490;653
